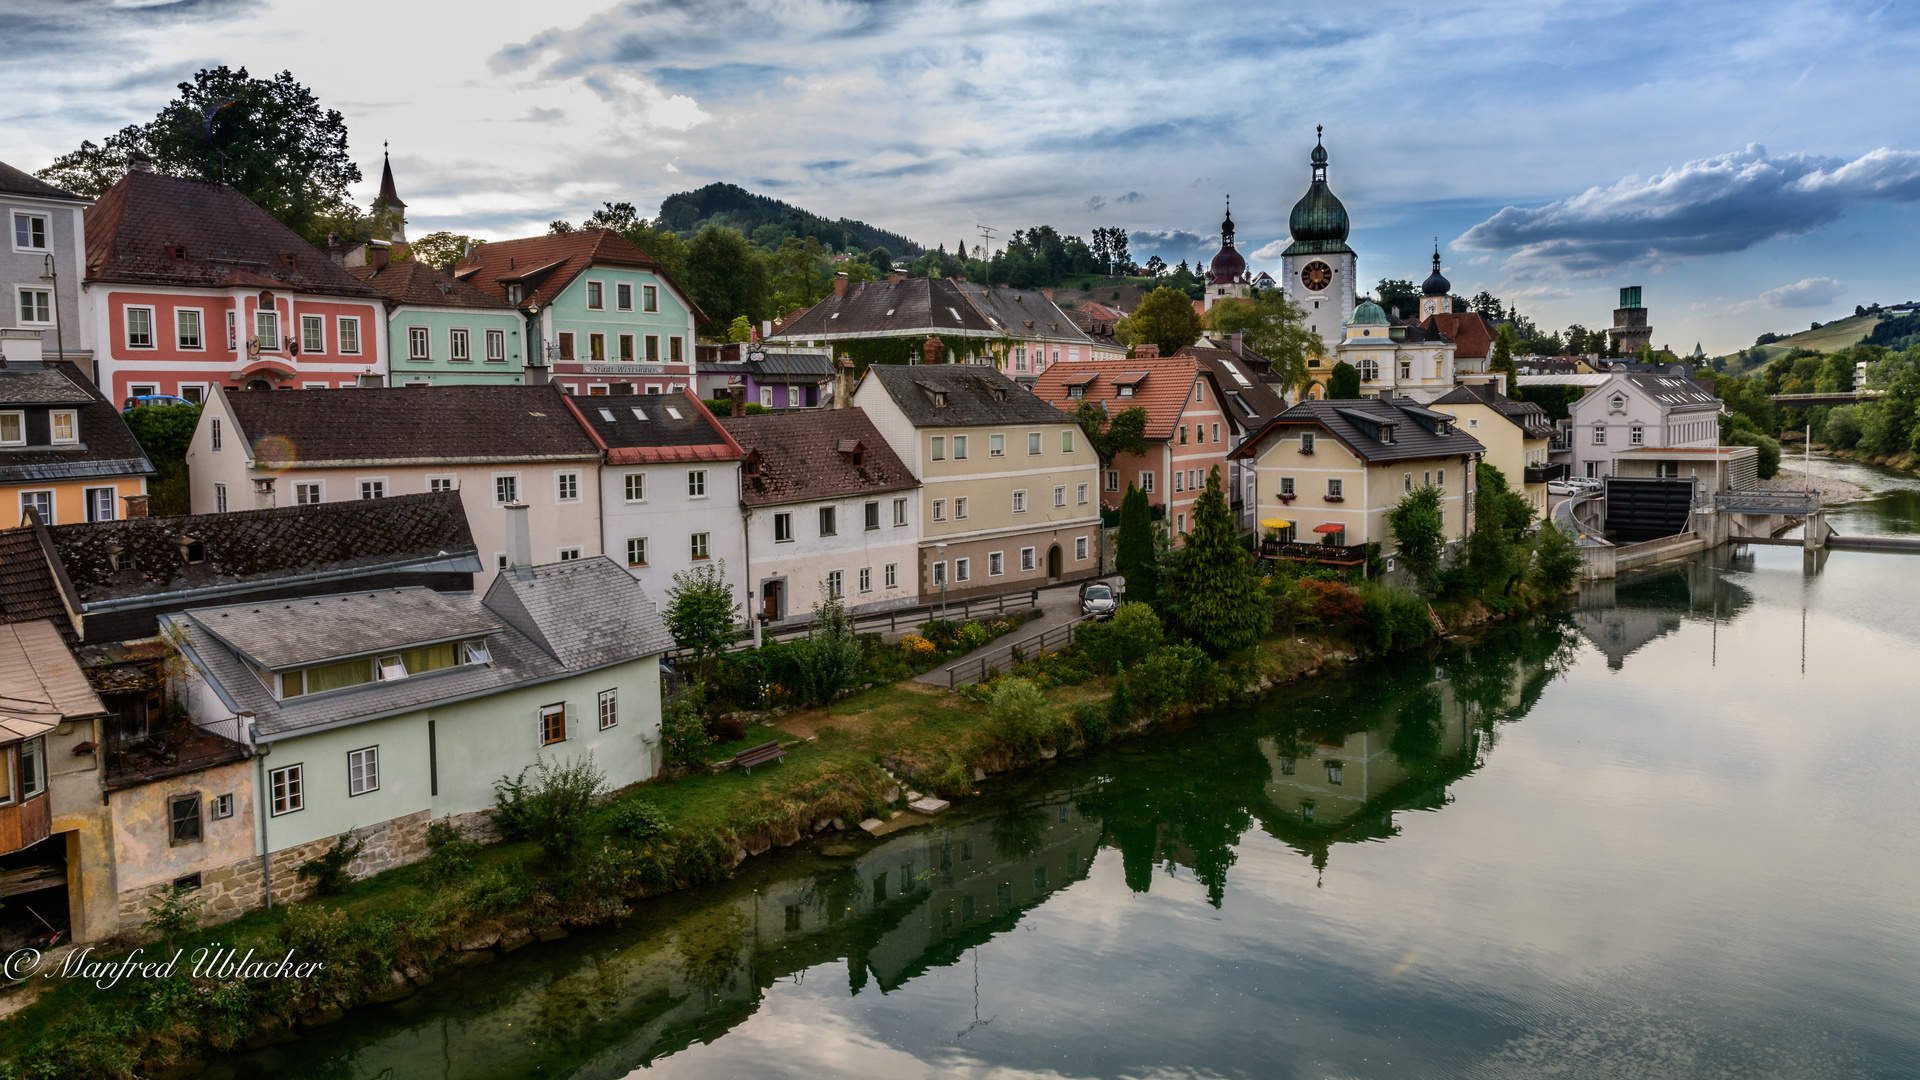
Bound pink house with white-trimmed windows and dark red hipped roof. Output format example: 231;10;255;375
86;163;388;402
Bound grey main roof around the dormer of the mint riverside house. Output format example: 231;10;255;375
163;555;672;740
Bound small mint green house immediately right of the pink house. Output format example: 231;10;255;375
346;259;540;386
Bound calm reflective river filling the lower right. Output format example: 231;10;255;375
205;459;1920;1080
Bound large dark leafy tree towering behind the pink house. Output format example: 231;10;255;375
38;65;361;242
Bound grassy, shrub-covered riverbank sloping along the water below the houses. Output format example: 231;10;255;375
0;582;1555;1080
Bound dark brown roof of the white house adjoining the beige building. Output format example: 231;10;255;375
720;409;920;505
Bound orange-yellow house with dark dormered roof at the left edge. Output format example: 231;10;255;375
0;331;154;528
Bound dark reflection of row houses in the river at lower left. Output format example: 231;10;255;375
266;799;1102;1076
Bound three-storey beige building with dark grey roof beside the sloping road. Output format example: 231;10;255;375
852;363;1100;603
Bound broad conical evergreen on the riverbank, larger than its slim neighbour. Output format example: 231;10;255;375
1175;465;1273;655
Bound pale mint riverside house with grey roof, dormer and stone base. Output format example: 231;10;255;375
161;549;672;901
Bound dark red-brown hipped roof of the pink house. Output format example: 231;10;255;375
86;173;380;300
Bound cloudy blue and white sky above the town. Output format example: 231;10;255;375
0;0;1920;352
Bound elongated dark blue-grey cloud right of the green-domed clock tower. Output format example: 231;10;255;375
1453;144;1920;277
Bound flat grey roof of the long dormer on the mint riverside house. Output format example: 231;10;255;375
186;586;501;671
